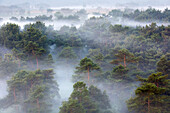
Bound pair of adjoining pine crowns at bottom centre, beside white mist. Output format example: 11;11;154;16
59;82;110;113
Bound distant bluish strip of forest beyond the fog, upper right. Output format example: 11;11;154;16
108;7;170;22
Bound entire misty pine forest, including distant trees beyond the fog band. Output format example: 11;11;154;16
0;5;170;113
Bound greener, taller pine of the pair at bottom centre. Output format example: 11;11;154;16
59;82;98;113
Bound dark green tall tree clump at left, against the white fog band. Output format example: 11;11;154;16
0;22;48;60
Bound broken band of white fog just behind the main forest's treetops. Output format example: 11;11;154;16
0;18;170;31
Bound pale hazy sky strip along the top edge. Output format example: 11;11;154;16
0;0;170;6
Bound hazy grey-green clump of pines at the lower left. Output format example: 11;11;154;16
0;69;59;113
